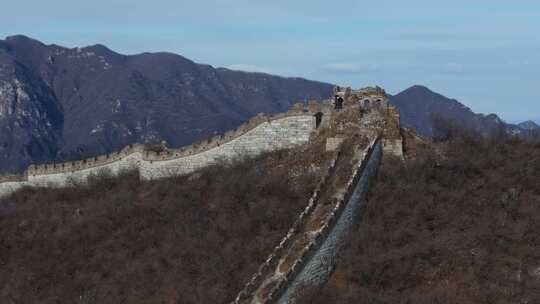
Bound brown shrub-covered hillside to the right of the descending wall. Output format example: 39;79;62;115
313;125;540;303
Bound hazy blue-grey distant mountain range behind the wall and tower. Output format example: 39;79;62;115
0;36;539;172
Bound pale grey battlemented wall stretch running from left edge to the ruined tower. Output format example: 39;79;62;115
0;110;318;197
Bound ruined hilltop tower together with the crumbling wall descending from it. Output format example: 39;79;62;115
233;88;403;304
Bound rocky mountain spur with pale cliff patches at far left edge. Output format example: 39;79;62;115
0;49;63;171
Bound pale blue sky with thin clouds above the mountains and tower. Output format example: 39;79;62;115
0;0;540;121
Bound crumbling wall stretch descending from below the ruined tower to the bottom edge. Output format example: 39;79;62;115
234;137;382;304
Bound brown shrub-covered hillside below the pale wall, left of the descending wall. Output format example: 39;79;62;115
0;151;325;304
